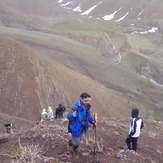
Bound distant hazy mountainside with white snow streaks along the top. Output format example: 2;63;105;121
1;0;163;31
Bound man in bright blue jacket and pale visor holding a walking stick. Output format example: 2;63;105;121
67;93;96;152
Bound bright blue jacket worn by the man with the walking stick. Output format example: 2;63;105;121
67;100;94;137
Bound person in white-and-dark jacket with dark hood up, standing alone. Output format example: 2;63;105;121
126;108;144;151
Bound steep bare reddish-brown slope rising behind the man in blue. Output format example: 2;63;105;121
0;38;129;125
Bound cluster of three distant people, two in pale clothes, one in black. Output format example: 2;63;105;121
41;104;66;122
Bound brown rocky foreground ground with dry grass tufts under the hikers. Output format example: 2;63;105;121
0;117;163;163
